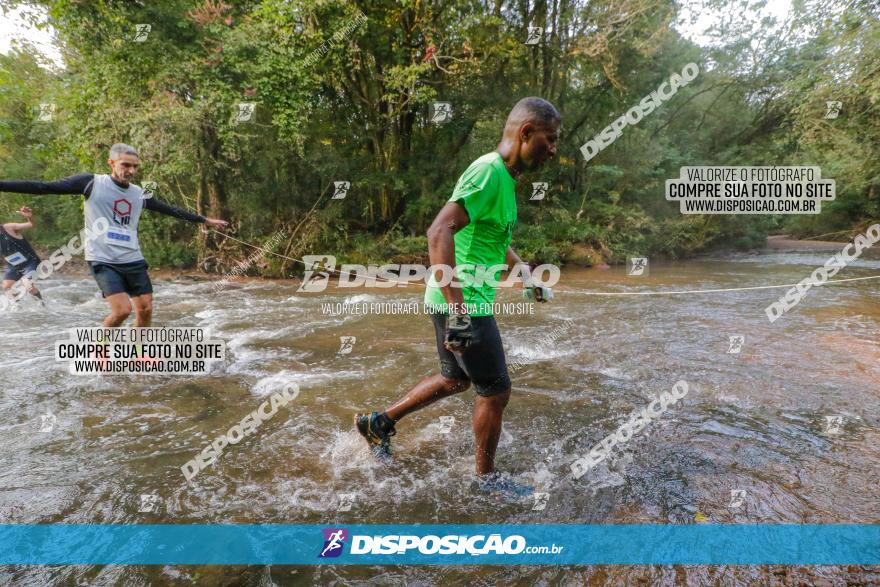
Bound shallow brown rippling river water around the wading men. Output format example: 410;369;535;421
0;252;880;585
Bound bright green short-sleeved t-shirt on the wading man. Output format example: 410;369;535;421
425;151;516;316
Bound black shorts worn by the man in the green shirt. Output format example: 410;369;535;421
430;313;510;396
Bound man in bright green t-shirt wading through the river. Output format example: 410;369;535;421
355;97;561;486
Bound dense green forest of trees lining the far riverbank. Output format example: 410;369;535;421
0;0;880;276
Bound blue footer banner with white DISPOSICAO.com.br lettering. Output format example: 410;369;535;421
0;524;880;565
